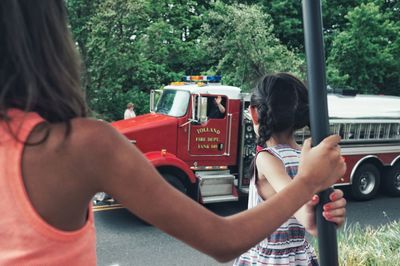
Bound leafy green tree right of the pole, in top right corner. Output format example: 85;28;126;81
328;3;400;95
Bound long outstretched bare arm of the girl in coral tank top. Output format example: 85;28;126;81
68;120;345;261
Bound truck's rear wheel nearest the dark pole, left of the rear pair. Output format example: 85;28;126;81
351;163;381;200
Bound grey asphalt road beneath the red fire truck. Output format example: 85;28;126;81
95;193;400;266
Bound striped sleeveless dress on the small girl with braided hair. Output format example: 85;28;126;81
234;145;318;266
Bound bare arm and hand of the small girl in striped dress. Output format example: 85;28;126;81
256;152;346;236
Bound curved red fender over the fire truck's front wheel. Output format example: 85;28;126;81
144;151;196;183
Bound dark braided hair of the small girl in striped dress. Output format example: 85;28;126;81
250;73;309;147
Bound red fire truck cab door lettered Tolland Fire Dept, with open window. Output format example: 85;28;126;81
188;95;232;156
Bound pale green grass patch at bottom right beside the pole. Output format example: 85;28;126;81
312;221;400;266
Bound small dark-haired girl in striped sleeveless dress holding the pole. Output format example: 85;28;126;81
234;73;345;266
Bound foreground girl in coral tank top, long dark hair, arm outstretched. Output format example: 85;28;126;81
0;0;346;265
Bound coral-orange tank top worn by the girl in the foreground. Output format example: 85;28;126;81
0;109;96;265
